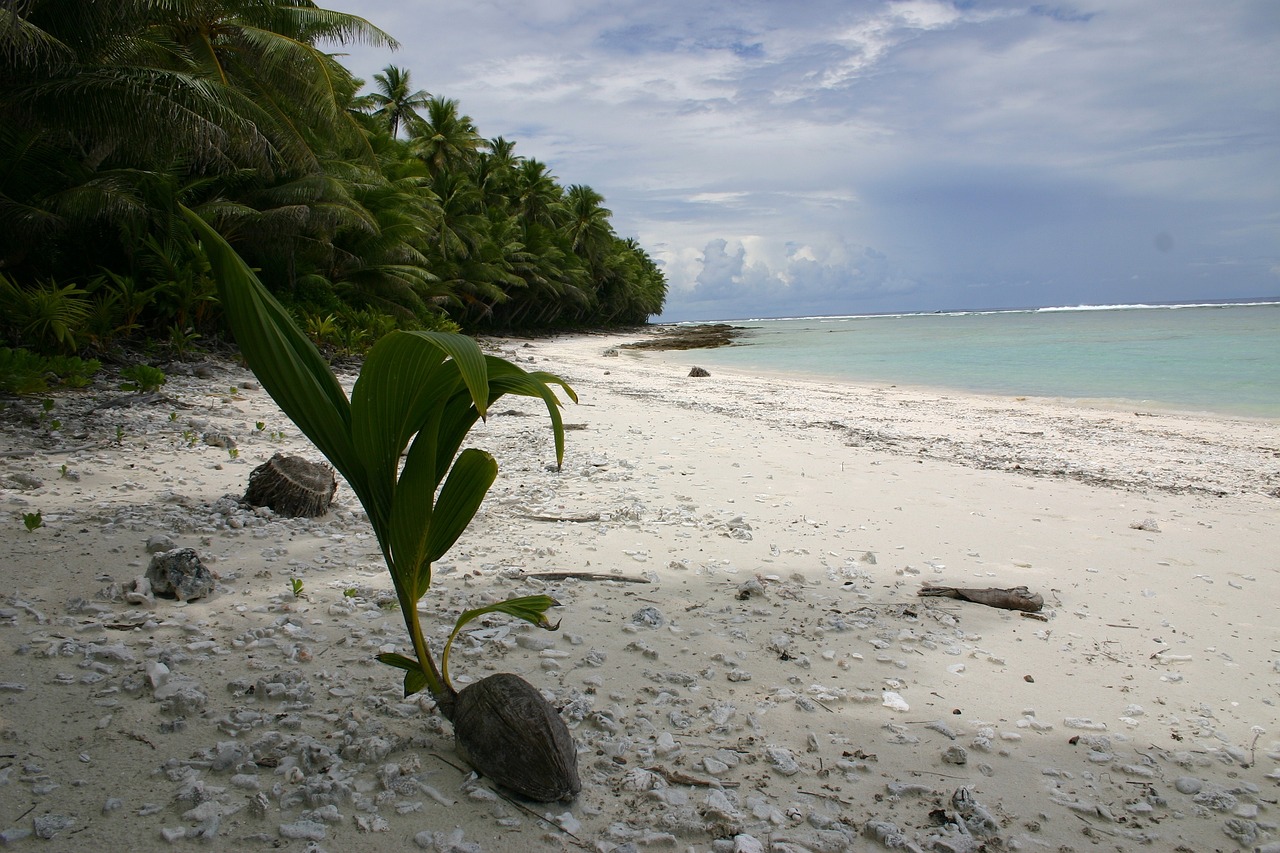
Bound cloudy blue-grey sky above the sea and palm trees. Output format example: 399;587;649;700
330;0;1280;321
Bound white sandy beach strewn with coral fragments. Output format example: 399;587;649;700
0;332;1280;853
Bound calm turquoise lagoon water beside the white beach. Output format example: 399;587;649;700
675;302;1280;419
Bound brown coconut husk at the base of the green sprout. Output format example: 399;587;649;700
449;672;582;803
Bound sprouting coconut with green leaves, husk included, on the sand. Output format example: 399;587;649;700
183;209;581;802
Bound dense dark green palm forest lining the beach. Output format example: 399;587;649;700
0;0;667;393
